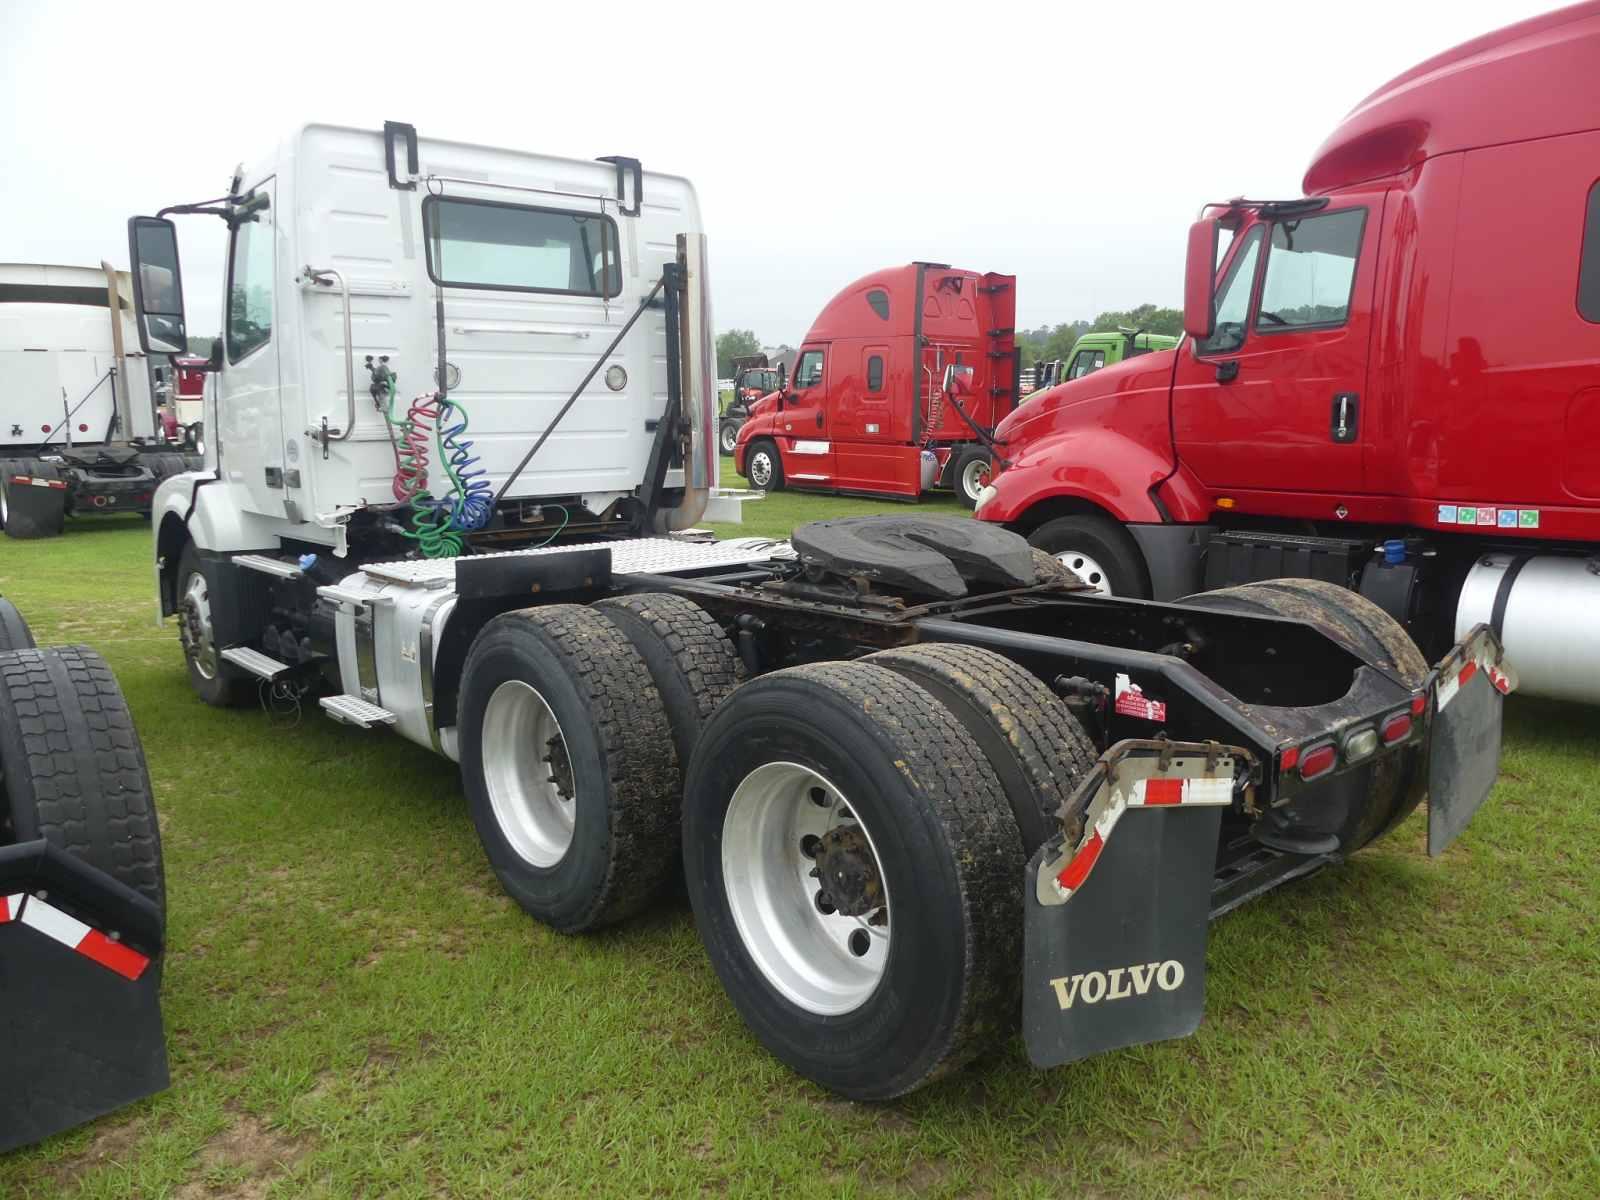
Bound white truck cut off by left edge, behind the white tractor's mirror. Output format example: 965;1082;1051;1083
0;262;198;538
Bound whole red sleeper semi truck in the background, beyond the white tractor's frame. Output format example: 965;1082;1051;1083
733;262;1021;504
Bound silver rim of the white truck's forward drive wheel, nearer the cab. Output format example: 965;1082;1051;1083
483;678;578;867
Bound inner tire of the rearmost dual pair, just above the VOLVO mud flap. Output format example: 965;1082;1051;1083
862;643;1099;858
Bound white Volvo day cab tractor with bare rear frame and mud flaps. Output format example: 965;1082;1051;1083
130;123;1514;1099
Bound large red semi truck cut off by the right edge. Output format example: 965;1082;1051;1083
978;3;1600;702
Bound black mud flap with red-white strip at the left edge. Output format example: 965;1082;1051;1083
0;840;168;1154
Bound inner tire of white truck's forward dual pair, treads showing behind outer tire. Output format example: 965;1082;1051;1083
595;592;744;787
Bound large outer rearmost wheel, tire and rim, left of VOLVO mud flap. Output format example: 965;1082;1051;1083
683;662;1024;1101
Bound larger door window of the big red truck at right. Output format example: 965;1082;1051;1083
1256;208;1366;333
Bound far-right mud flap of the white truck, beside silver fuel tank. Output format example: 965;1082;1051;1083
1427;626;1515;854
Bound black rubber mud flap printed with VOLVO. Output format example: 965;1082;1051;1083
1022;806;1222;1067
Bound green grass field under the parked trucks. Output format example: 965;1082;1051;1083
0;508;1600;1198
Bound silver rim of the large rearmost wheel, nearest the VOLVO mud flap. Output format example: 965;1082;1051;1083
722;762;890;1016
